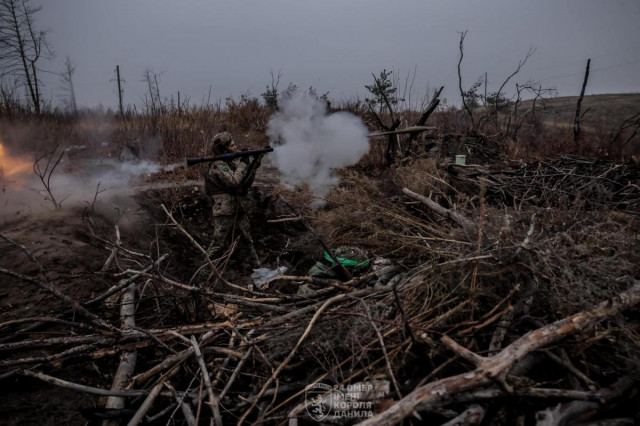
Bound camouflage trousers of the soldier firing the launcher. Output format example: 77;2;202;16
207;213;260;267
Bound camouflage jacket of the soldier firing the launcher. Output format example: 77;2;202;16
204;158;255;216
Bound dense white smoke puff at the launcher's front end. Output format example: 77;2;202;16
267;93;369;196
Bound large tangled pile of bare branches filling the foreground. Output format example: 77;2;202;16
0;180;640;425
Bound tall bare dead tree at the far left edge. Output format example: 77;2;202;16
0;0;52;114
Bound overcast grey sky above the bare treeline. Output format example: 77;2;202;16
32;0;640;109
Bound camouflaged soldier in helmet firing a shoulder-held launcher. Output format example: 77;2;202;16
204;132;262;267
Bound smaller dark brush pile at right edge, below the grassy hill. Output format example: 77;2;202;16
448;156;640;212
